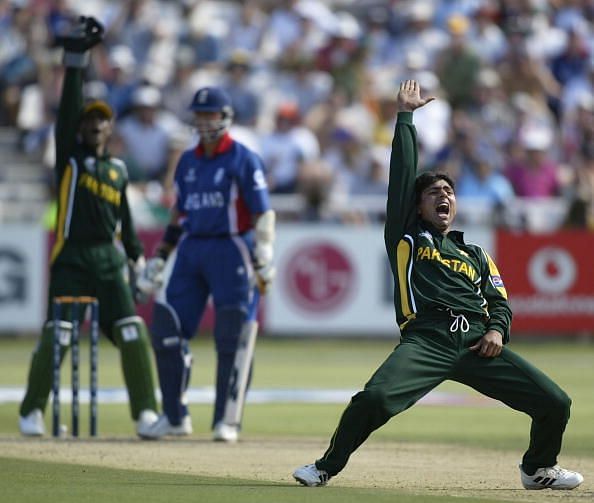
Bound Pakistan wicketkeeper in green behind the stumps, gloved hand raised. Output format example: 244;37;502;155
19;18;158;436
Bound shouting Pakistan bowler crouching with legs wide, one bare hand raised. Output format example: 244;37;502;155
293;80;583;489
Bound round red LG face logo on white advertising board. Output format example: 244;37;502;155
285;243;355;312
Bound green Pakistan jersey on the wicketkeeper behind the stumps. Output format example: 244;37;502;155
52;68;142;263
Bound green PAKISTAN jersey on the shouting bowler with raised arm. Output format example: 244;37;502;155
384;112;511;342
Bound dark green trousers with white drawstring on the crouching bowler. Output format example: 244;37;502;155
316;312;571;476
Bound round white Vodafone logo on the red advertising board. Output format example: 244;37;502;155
528;246;577;294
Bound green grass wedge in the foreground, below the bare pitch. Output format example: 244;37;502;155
0;457;512;503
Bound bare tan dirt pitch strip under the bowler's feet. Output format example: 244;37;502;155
0;436;594;503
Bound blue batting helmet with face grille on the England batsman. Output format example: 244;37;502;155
189;87;233;142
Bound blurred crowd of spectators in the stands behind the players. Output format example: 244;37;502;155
0;0;594;230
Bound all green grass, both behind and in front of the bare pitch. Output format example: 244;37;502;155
0;337;594;503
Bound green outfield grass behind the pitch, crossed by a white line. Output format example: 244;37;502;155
0;337;594;457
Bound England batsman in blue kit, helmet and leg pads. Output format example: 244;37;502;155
139;87;275;442
